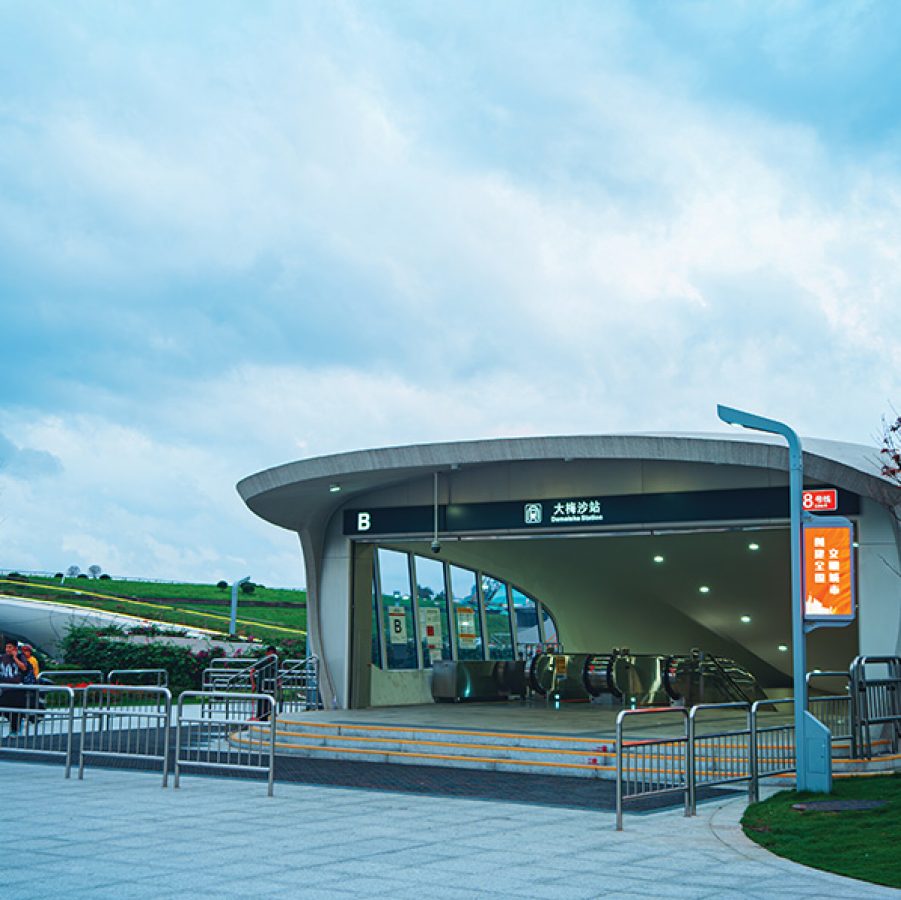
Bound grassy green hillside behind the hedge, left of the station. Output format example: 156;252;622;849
0;578;307;641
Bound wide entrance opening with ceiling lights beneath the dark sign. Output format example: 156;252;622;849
350;524;857;707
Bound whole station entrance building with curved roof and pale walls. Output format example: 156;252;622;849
238;430;901;711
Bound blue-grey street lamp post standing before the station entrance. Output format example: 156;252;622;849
716;404;832;794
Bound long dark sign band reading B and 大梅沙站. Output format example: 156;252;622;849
343;487;860;536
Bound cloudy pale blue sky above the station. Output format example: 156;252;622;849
0;0;901;584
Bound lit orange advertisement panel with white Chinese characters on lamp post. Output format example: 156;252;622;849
803;518;855;620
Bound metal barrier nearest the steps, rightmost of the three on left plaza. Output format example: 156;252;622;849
174;691;276;797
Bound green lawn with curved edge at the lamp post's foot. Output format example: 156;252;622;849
742;774;901;888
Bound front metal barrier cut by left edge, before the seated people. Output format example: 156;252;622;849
0;684;75;778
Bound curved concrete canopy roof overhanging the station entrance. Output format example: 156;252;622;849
237;431;901;531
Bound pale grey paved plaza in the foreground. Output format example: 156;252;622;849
0;760;901;900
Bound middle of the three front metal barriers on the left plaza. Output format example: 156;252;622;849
78;684;172;787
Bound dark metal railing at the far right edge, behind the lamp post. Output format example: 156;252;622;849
851;656;901;759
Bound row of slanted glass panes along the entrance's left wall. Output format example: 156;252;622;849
372;547;557;669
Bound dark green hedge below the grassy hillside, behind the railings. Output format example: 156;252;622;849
62;628;224;698
